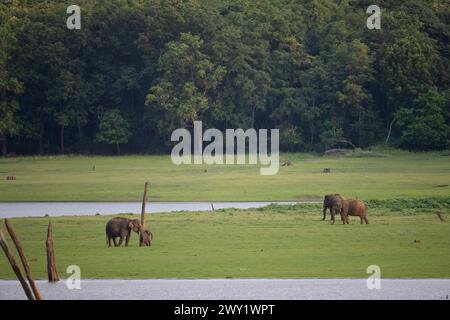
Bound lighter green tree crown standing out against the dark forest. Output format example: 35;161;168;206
146;33;225;135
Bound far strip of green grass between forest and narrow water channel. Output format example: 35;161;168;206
0;151;450;201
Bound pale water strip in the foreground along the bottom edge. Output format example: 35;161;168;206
0;279;450;300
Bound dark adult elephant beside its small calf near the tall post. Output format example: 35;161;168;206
106;218;144;247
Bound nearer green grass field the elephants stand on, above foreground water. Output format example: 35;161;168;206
0;201;450;279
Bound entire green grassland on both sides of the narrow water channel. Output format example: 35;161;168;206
0;151;450;279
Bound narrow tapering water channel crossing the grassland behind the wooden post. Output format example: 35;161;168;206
0;202;310;218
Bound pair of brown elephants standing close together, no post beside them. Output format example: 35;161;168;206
322;194;369;224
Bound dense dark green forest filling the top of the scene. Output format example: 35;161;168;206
0;0;450;155
